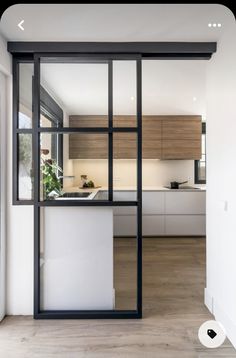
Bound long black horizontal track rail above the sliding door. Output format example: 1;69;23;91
8;41;217;60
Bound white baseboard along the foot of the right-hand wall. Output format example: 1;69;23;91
204;288;236;349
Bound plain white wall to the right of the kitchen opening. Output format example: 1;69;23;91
205;8;236;347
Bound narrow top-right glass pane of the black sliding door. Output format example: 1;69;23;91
113;61;137;127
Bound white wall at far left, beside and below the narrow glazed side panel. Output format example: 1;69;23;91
0;32;33;314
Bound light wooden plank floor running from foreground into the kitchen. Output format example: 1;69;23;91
0;238;236;358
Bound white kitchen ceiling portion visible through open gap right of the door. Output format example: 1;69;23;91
142;60;207;119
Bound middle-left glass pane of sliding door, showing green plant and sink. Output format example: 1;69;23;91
40;133;108;200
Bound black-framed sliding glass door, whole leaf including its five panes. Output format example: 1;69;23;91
30;54;142;318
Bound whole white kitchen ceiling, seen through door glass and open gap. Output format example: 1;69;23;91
38;60;207;115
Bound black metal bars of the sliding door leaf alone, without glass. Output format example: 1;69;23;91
33;53;142;319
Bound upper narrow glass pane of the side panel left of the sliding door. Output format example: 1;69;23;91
18;63;33;128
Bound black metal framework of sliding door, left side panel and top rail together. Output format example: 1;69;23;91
8;42;217;319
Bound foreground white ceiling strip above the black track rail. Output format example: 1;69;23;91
0;4;235;41
